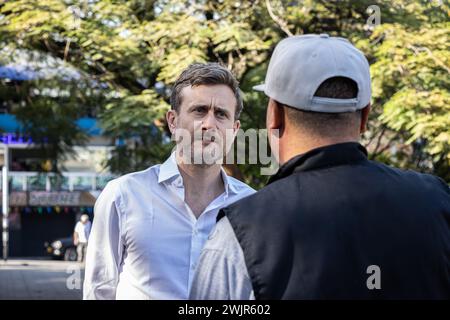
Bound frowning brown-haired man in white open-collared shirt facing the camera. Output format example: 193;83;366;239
83;63;254;299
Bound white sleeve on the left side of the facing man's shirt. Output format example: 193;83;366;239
83;180;124;300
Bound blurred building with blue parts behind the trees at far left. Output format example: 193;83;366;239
0;66;113;256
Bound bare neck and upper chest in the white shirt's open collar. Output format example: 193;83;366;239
177;154;225;218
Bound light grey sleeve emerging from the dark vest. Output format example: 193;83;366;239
189;217;254;300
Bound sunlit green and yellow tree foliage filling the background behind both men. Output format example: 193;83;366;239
0;0;450;186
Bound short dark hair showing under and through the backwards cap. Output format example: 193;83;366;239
282;77;361;135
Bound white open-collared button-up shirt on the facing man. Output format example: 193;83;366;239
83;153;254;299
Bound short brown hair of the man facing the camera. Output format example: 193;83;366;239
170;63;243;120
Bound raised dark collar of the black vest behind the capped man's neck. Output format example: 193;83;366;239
267;142;367;184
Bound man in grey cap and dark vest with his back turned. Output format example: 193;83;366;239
190;34;450;299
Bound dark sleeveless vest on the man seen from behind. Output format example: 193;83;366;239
219;143;450;299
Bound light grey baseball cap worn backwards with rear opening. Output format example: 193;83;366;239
253;34;371;113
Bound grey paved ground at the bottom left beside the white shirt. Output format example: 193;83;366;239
0;259;84;300
